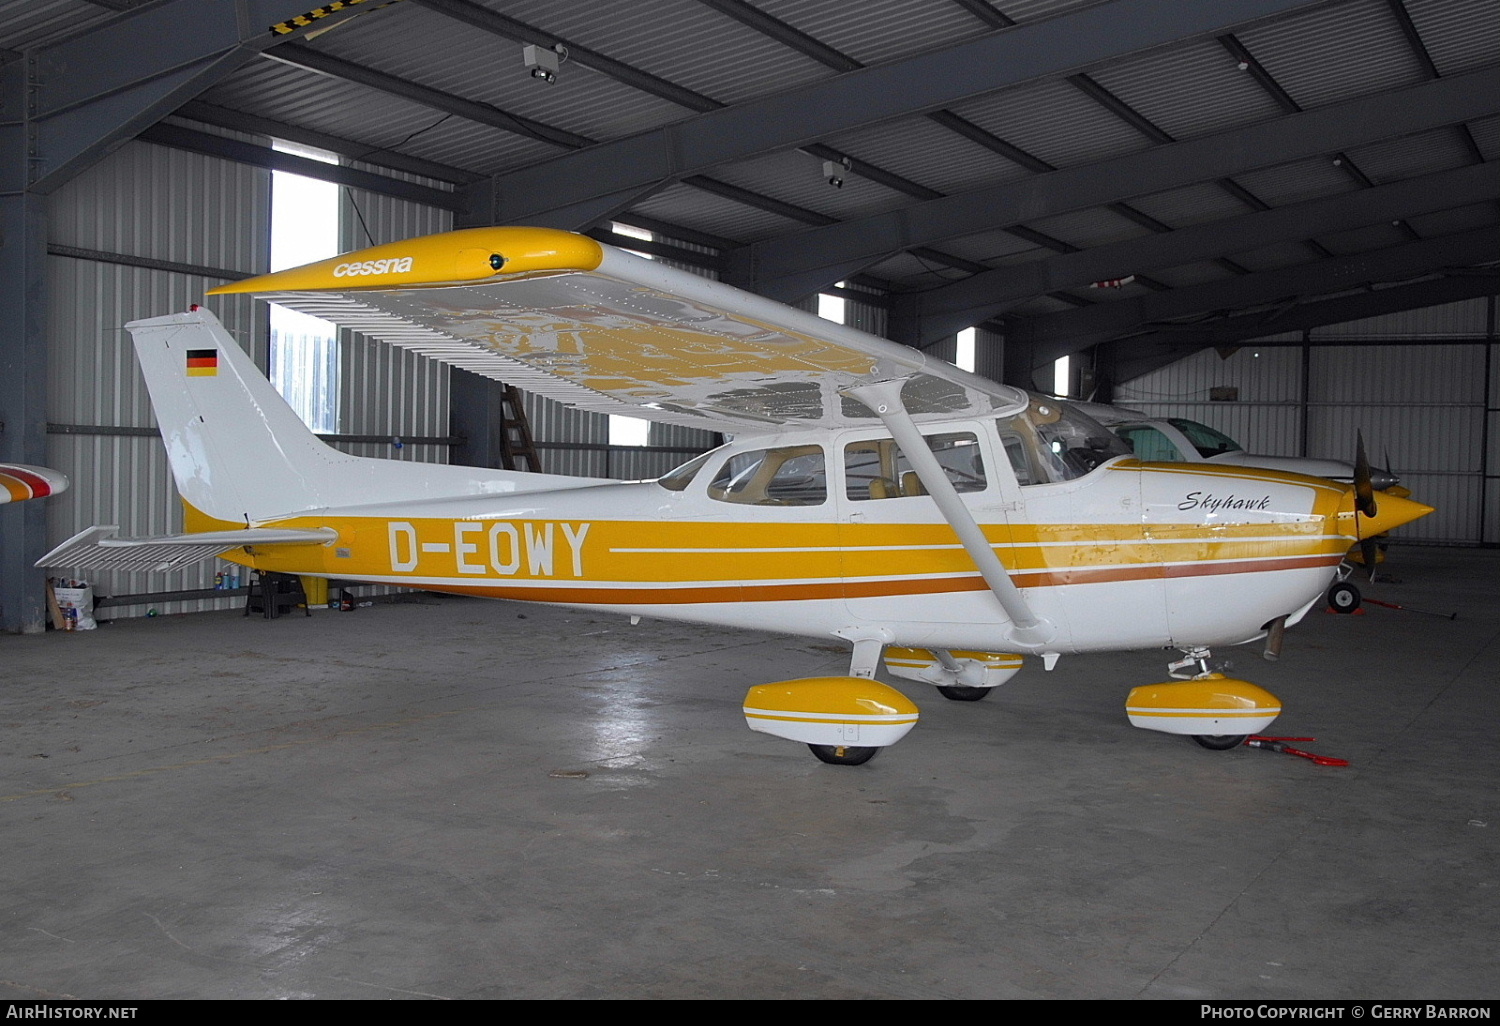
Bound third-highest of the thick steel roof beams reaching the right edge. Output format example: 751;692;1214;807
1010;225;1500;366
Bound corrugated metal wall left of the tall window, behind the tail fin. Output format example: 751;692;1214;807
47;143;270;617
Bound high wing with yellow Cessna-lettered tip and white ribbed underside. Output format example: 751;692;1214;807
213;228;1026;435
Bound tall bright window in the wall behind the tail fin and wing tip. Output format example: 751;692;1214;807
270;140;339;434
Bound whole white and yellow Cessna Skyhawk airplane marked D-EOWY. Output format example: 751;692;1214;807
42;228;1430;764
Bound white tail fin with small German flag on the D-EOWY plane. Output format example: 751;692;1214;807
126;309;599;525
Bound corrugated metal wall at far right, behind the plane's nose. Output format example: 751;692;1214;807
1116;300;1500;545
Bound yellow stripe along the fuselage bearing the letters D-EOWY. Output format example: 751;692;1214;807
217;515;1350;605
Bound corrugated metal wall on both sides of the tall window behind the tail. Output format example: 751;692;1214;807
48;137;452;618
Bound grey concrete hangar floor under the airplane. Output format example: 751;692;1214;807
0;548;1500;1001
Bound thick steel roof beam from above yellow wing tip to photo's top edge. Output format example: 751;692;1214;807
480;0;1317;222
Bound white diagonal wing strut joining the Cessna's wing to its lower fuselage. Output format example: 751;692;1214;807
846;378;1058;653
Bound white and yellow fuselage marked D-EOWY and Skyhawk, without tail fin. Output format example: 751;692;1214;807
225;420;1416;653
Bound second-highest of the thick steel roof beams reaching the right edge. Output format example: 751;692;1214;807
894;164;1500;344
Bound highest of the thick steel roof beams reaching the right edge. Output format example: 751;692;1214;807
734;66;1500;299
